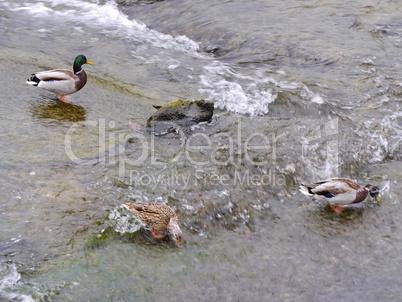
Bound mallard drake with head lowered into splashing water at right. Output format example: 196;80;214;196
300;178;380;213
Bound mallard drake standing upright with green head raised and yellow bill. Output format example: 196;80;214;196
26;55;92;103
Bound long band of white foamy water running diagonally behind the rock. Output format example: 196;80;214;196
0;0;323;116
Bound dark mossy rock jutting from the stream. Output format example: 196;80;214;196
147;99;214;135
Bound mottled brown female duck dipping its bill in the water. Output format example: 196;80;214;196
123;202;182;247
